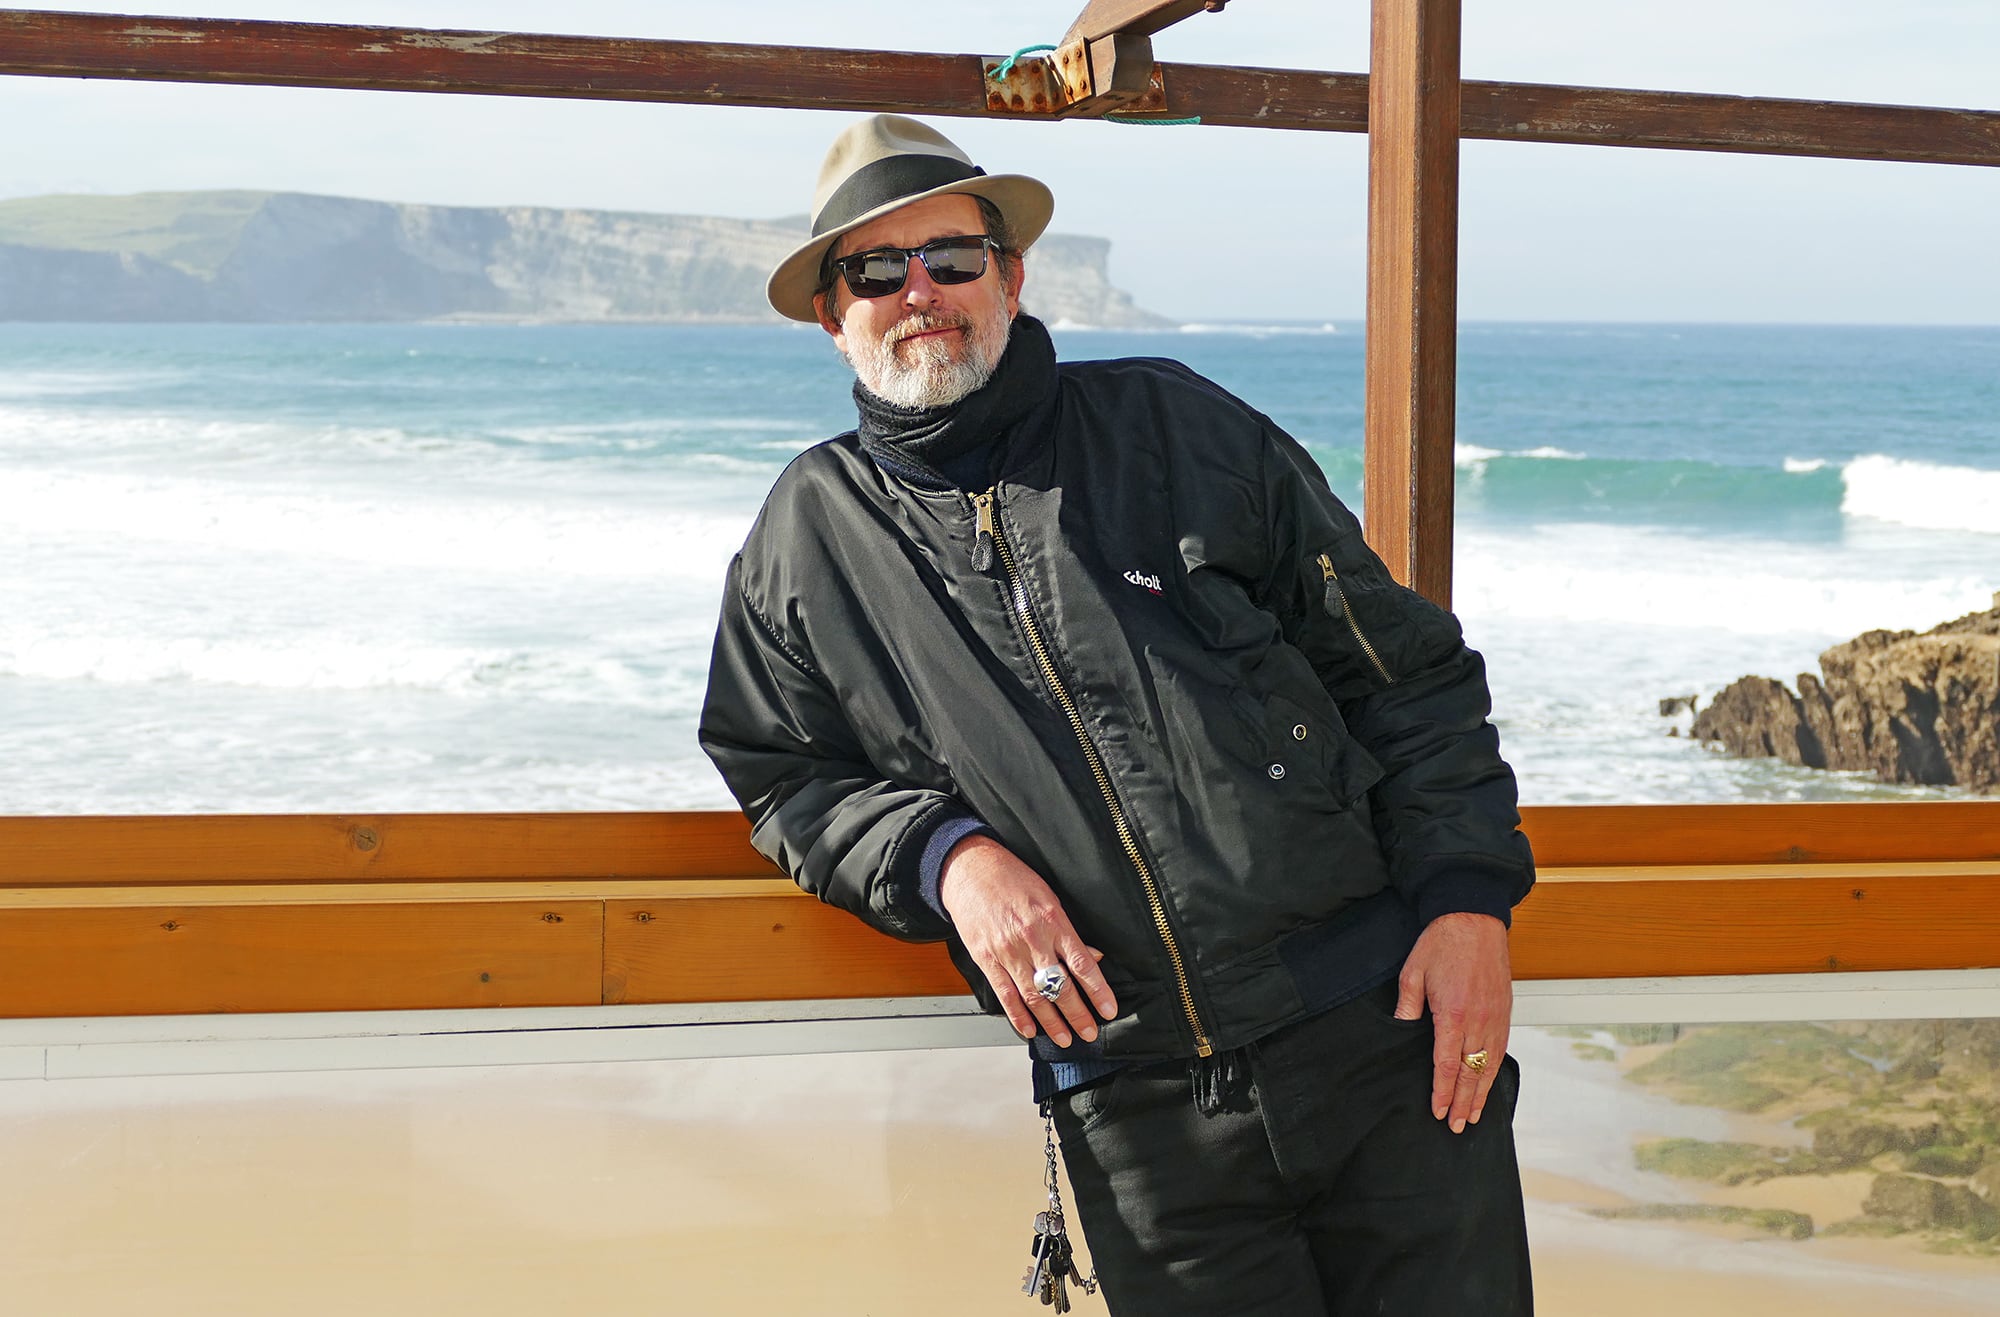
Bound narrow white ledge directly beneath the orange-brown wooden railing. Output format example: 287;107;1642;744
0;969;2000;1079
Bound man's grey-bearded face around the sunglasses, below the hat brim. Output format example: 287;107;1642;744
816;194;1020;408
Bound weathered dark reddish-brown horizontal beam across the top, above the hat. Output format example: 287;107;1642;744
0;10;2000;166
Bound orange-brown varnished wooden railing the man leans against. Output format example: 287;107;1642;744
0;801;2000;1017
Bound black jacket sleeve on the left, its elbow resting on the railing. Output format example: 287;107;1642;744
700;556;980;941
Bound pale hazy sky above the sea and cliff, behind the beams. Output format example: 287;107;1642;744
0;0;2000;324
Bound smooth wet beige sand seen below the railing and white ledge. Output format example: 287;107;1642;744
0;1037;2000;1317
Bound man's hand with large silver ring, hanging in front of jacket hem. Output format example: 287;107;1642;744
938;833;1118;1047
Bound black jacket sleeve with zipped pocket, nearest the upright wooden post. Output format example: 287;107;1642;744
1262;426;1534;923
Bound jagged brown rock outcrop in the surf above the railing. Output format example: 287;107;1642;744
1694;596;2000;791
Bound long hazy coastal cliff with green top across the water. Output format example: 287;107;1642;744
0;192;1174;328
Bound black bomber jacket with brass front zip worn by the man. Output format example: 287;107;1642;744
700;334;1534;1061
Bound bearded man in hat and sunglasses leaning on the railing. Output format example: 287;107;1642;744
702;116;1532;1317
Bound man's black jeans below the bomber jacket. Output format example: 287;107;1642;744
1056;983;1534;1317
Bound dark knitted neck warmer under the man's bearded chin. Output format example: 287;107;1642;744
854;314;1056;490
